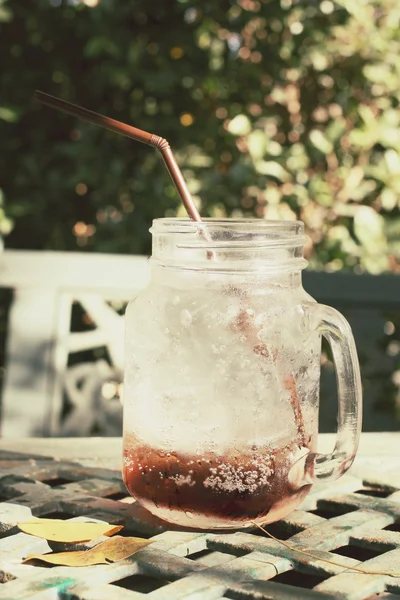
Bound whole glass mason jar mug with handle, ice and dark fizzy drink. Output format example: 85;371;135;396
123;219;361;528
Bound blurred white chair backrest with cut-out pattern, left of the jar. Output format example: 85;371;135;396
0;250;150;437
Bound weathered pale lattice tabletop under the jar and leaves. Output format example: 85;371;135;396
0;440;400;600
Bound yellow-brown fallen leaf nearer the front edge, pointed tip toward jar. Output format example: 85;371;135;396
23;535;153;567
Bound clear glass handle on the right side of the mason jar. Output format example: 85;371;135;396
304;304;362;482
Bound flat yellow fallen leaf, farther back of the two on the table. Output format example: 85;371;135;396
17;519;123;543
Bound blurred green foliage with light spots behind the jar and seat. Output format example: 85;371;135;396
0;0;400;431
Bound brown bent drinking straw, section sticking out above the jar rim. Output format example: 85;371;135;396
33;90;201;222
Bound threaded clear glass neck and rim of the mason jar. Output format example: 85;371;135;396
150;218;307;272
